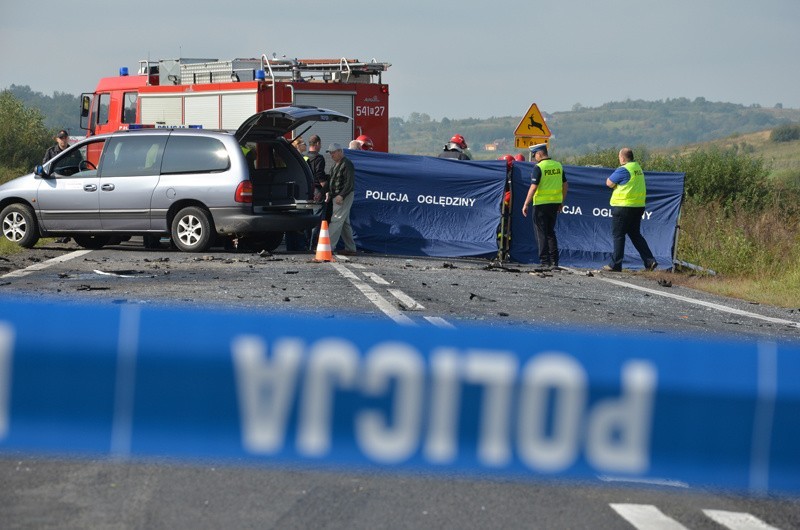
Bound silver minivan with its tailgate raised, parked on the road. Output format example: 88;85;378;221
0;106;350;252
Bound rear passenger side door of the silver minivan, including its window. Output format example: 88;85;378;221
98;132;168;228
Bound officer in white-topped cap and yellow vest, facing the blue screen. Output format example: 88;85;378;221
522;144;568;269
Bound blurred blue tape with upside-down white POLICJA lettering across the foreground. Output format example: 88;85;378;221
0;299;800;493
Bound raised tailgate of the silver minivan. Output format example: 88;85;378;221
236;106;350;142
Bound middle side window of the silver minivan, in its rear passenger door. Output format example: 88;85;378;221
98;134;167;178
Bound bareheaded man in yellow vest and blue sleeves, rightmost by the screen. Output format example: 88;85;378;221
603;147;658;272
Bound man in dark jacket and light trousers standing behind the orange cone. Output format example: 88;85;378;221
328;143;356;256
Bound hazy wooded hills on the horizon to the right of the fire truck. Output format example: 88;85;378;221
389;98;800;158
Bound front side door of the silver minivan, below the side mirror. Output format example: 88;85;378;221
36;139;104;232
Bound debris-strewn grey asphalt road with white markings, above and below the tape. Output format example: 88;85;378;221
0;239;800;529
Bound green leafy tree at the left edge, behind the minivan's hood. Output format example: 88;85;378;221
0;90;53;172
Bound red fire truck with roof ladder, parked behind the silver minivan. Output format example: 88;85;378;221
81;54;391;151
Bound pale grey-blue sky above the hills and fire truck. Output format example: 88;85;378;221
0;0;800;120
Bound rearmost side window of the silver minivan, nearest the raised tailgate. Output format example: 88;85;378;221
161;134;231;174
